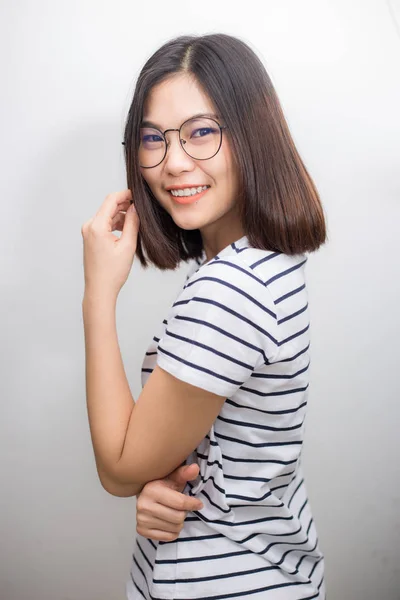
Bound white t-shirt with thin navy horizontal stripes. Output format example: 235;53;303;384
126;236;325;600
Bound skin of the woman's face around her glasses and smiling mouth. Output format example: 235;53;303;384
141;74;242;241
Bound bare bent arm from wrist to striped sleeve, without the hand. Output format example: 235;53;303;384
83;287;225;496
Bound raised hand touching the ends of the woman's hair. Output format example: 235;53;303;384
81;189;140;297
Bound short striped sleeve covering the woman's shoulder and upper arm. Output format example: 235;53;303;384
157;258;277;397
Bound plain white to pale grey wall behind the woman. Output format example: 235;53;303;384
0;0;400;600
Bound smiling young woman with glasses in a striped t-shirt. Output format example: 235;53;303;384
82;34;326;600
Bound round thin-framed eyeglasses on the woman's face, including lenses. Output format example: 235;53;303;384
122;116;227;169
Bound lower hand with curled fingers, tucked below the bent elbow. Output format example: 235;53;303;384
136;463;204;542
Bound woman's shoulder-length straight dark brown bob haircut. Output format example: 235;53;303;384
122;33;326;270
